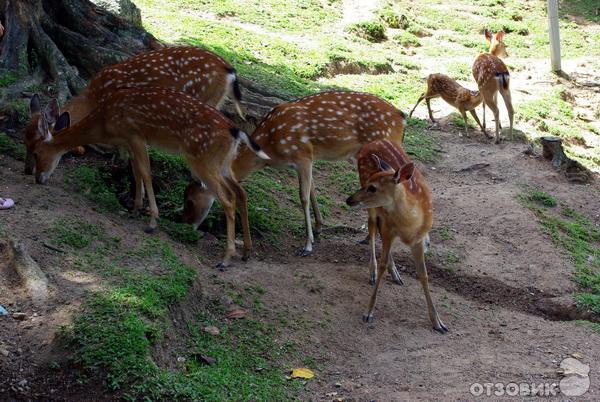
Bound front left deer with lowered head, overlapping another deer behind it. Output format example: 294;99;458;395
25;87;268;266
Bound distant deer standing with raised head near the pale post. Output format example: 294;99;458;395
473;29;514;144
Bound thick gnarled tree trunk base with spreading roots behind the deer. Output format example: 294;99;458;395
0;0;162;102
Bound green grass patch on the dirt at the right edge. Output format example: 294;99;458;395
518;187;600;314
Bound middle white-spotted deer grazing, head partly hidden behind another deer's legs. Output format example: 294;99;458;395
184;91;406;256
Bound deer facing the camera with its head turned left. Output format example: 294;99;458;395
346;140;448;333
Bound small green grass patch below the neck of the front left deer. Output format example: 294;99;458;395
69;165;123;212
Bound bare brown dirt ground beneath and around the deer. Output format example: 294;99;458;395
0;105;600;401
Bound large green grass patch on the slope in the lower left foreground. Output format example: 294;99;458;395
58;232;298;401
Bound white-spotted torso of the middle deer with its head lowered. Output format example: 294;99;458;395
238;91;406;170
